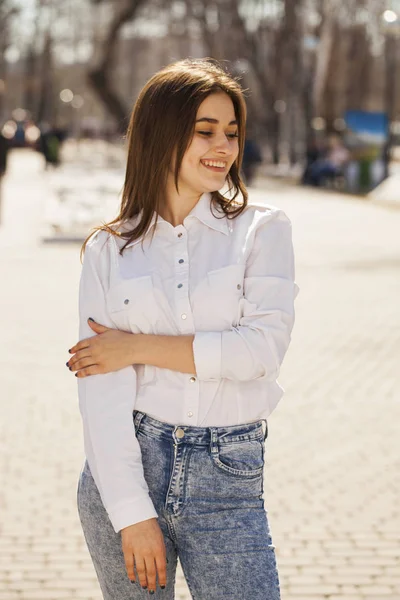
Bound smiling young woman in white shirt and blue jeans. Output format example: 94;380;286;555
67;60;297;600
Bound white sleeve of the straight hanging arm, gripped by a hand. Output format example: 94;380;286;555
78;235;157;532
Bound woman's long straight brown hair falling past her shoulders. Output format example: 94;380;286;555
82;59;247;254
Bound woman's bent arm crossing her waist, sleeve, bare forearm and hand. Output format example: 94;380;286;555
69;211;298;381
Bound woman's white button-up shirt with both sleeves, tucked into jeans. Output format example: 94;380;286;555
78;194;298;531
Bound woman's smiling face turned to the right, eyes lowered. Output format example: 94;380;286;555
174;92;239;195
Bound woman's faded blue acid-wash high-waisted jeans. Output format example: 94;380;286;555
78;411;280;600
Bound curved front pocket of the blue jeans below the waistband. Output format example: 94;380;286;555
211;439;264;478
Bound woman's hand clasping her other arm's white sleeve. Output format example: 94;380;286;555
67;319;134;377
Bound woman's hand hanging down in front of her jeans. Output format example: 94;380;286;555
121;519;167;593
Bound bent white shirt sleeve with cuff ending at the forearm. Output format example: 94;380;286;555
193;210;298;381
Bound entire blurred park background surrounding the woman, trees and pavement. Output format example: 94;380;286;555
0;0;400;600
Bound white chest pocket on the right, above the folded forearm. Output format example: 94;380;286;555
196;265;245;331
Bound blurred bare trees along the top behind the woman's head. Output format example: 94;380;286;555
0;0;400;164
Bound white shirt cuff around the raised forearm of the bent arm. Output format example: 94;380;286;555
193;331;222;381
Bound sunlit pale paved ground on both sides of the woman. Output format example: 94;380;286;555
0;146;400;600
